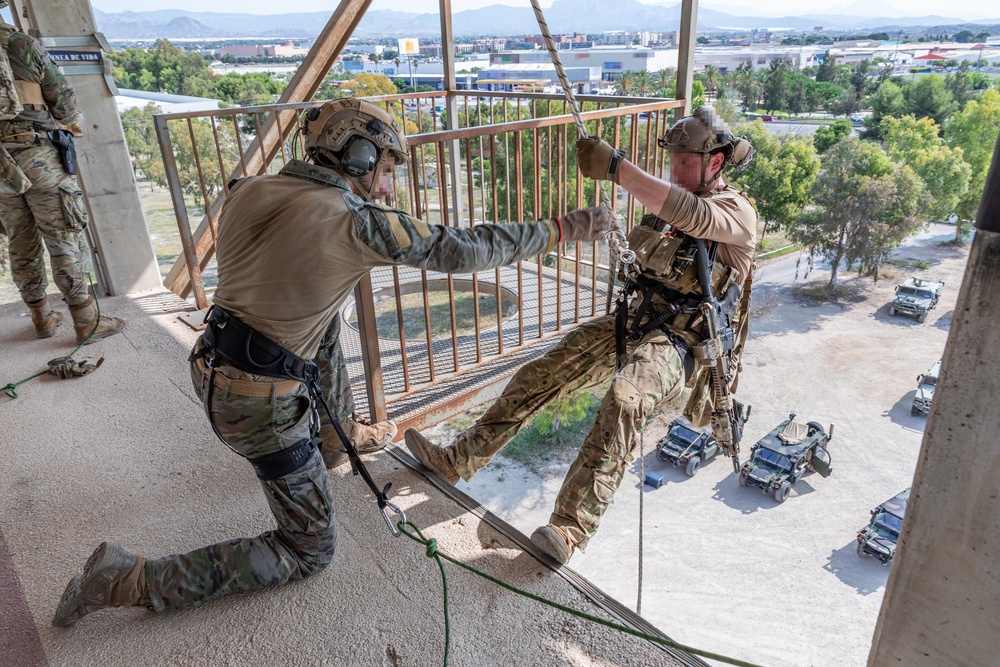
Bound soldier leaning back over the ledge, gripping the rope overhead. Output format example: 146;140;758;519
405;107;757;563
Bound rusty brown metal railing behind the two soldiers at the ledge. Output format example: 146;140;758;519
155;91;682;426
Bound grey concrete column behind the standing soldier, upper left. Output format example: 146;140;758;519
15;0;161;295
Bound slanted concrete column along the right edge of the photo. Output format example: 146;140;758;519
868;129;1000;667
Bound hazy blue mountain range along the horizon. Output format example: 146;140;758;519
94;0;1000;39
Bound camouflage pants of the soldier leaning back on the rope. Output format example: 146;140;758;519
455;315;684;549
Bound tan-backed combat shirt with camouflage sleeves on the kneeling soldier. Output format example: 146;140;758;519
215;160;559;359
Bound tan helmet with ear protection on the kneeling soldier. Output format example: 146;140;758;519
302;97;407;201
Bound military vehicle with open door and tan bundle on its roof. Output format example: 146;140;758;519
740;413;833;503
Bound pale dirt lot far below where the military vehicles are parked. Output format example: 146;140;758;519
428;225;968;667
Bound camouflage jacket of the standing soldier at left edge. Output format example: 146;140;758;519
0;22;82;135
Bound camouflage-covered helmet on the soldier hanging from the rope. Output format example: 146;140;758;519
657;106;754;190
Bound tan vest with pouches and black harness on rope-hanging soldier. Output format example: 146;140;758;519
616;213;740;379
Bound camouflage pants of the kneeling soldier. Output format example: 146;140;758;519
146;341;337;611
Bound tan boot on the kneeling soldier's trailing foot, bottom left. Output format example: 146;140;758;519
52;542;152;627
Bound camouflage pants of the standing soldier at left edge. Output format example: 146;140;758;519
0;141;88;306
